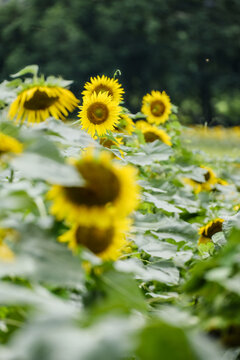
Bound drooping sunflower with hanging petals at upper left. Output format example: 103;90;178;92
8;85;79;123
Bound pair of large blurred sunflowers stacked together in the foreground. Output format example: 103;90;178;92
48;149;139;260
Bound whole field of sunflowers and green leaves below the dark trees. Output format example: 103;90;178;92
0;65;240;360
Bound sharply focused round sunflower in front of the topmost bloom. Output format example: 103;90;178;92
79;92;120;136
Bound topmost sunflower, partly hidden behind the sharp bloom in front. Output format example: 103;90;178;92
82;75;124;103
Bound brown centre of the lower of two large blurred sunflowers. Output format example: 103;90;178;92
76;226;114;254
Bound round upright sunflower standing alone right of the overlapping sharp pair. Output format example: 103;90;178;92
141;90;171;125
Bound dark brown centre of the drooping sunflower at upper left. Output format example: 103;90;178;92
24;90;59;110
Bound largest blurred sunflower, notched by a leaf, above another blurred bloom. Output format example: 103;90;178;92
48;149;139;225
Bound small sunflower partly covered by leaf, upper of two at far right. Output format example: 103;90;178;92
184;166;219;194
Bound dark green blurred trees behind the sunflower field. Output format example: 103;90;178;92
0;0;240;126
